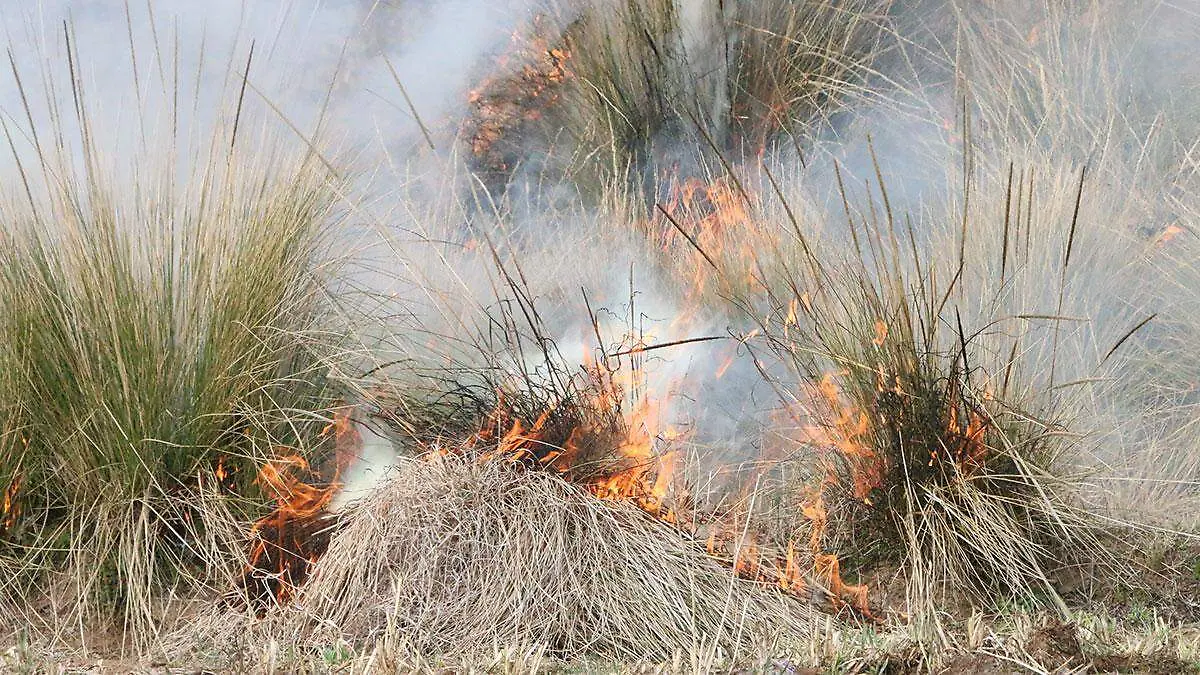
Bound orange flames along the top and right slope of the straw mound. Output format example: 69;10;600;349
412;326;877;616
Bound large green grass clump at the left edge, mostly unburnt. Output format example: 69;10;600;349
0;127;345;638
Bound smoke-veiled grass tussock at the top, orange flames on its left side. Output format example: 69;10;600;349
466;0;887;191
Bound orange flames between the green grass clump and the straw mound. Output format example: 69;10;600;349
237;410;362;610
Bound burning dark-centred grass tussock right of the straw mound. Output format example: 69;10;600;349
744;166;1116;620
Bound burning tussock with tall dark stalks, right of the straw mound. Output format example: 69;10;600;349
720;153;1136;629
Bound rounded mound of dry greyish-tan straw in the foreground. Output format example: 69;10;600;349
288;458;814;659
